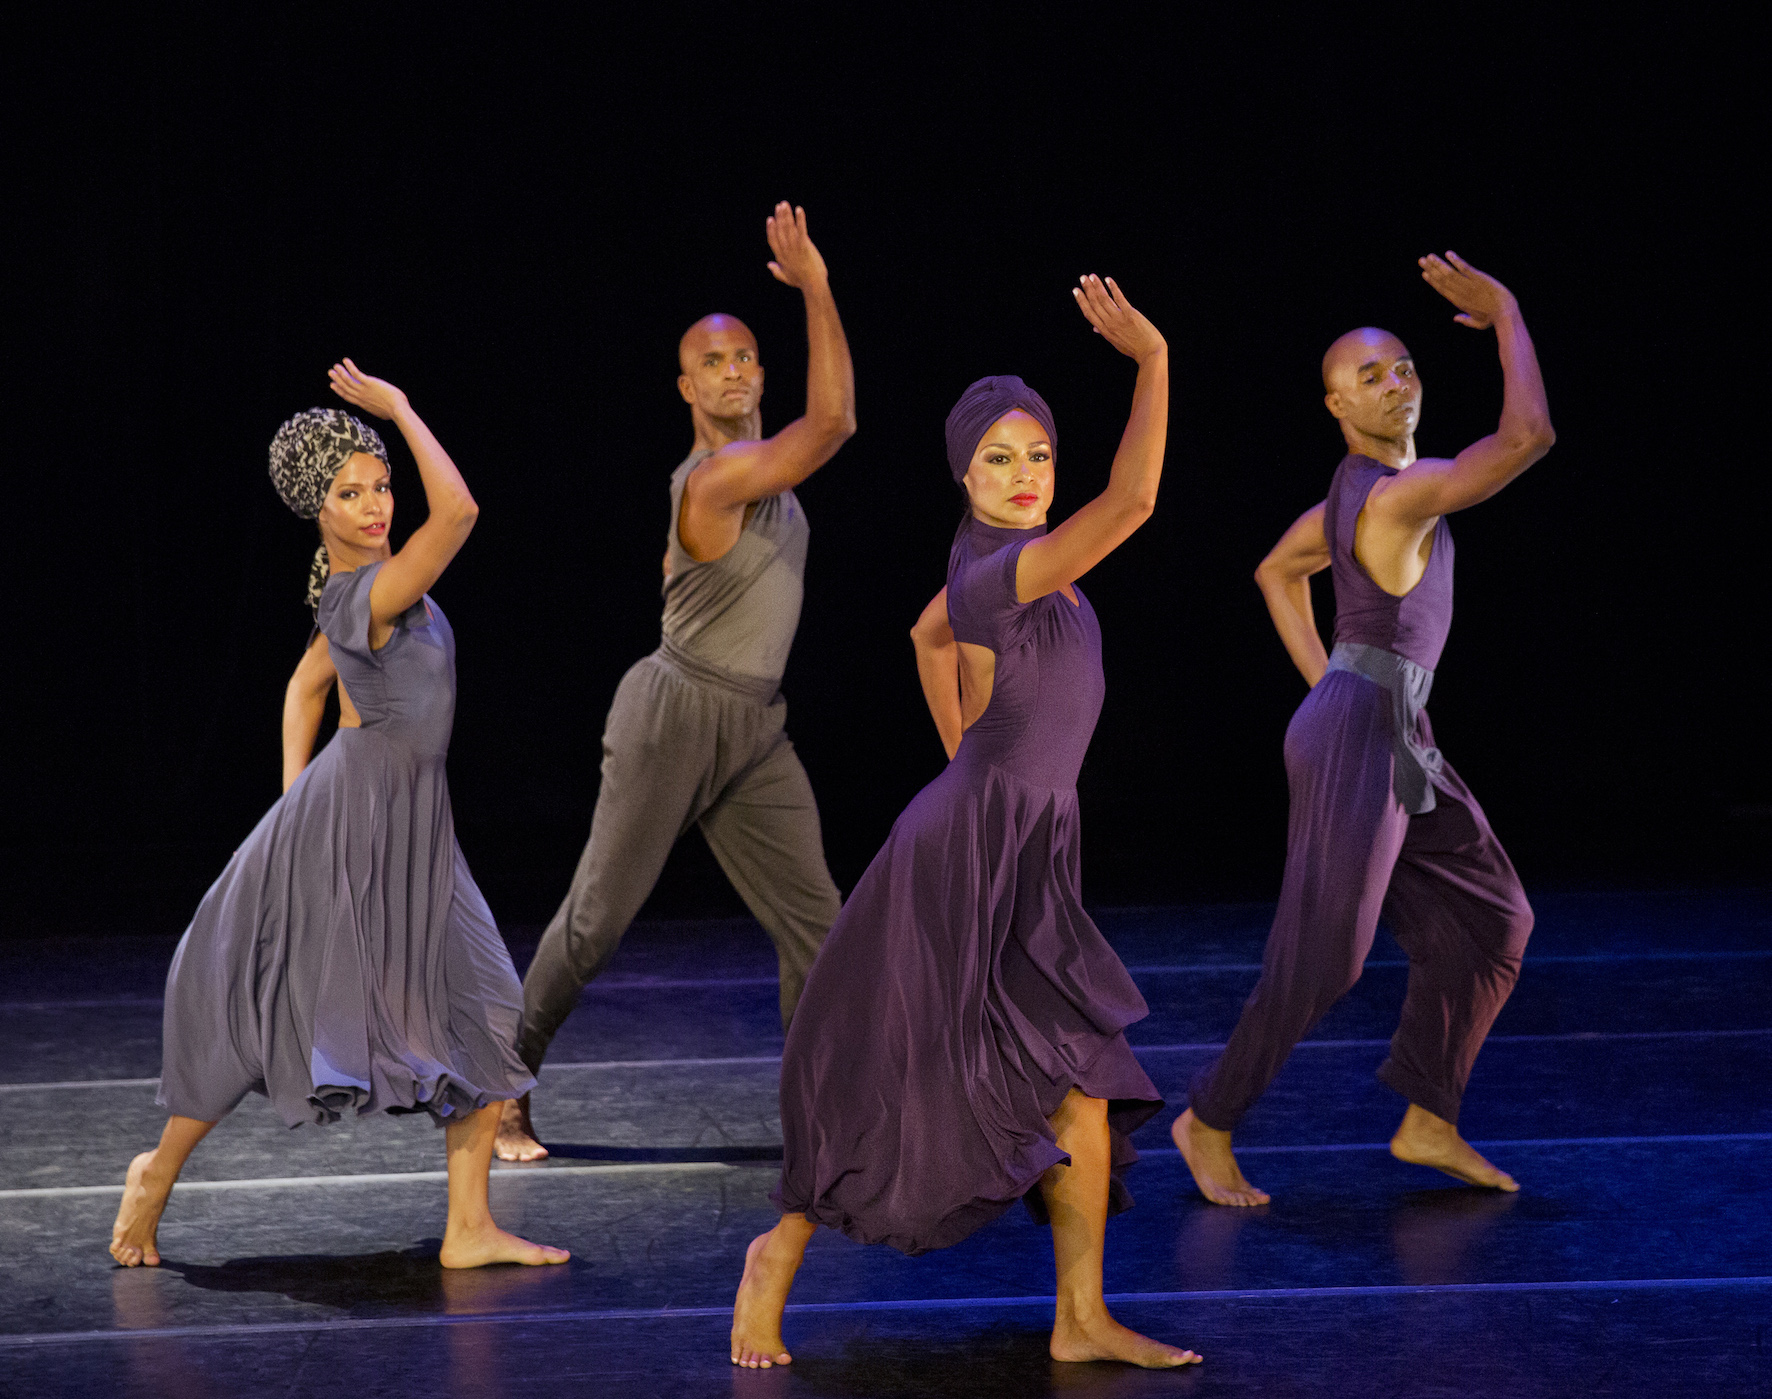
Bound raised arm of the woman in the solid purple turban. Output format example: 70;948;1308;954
1015;276;1170;602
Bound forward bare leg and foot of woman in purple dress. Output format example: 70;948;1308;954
1040;1089;1200;1369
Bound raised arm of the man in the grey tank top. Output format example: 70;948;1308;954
684;202;856;515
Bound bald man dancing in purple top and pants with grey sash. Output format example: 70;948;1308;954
1173;253;1556;1206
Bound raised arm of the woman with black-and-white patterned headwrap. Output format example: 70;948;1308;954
330;359;480;650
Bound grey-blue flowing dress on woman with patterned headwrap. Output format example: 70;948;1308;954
158;563;535;1126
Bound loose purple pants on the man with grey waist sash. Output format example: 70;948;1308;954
1189;671;1533;1132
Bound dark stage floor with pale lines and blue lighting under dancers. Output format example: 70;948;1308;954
0;893;1772;1399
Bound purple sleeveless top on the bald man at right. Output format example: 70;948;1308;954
1324;453;1453;671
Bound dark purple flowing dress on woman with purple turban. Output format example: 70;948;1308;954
774;517;1162;1254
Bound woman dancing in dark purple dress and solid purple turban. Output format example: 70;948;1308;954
732;276;1200;1369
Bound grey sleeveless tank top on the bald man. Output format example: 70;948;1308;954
663;450;812;684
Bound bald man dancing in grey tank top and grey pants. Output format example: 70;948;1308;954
498;204;856;1162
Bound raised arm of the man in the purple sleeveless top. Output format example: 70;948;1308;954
1366;251;1556;526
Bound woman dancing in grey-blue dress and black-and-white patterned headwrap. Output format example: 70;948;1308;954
110;359;567;1268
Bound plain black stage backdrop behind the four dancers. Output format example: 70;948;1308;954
0;9;1772;933
